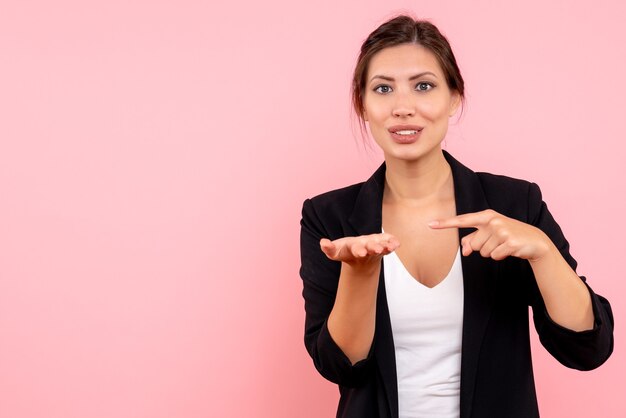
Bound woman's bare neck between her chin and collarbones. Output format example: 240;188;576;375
384;149;454;204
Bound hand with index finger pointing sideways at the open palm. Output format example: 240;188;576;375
428;209;552;261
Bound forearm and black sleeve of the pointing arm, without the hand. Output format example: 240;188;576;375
528;183;614;370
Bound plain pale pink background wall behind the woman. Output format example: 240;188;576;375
0;0;626;418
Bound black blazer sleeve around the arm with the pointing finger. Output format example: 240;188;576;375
528;183;613;370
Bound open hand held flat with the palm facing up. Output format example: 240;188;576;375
320;233;400;266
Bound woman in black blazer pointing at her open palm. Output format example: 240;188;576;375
300;16;613;418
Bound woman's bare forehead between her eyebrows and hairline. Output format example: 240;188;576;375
367;44;443;81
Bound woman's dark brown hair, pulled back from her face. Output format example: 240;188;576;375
352;15;465;132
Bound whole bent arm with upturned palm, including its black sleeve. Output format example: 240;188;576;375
300;200;394;386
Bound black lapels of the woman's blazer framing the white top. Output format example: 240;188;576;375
348;150;497;418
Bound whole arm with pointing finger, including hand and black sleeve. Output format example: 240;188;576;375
430;183;613;370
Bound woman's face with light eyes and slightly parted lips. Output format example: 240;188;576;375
363;44;461;161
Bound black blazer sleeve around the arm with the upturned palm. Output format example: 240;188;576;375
300;199;374;387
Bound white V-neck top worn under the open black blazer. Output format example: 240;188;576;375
383;248;463;418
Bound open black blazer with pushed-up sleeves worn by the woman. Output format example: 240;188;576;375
300;151;613;418
